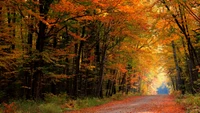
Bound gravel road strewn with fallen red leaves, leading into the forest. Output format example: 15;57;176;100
67;95;185;113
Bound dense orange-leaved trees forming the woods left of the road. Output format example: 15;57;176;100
0;0;152;101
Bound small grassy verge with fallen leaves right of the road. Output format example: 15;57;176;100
173;92;200;113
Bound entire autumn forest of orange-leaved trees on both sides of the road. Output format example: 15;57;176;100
0;0;200;102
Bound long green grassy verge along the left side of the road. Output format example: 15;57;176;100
0;93;138;113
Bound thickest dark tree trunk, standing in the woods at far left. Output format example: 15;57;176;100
32;0;53;99
